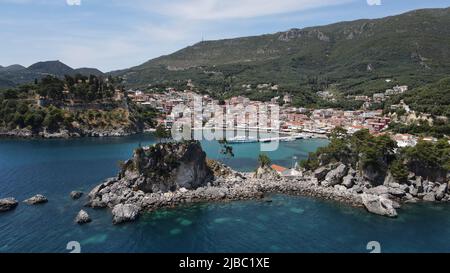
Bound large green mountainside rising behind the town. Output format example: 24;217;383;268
116;9;450;105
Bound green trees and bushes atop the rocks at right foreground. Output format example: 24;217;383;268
300;128;450;182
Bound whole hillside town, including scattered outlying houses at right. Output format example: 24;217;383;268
127;86;435;147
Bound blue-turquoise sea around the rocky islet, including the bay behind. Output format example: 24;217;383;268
0;135;450;252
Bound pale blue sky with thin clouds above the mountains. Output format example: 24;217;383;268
0;0;450;72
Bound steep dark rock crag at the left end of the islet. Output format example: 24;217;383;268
119;142;213;193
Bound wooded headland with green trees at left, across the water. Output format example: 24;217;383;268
0;75;157;134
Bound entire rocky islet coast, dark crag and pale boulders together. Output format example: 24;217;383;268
86;142;450;224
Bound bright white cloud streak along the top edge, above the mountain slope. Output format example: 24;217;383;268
148;0;355;20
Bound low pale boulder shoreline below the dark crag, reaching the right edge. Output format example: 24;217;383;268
85;167;450;224
